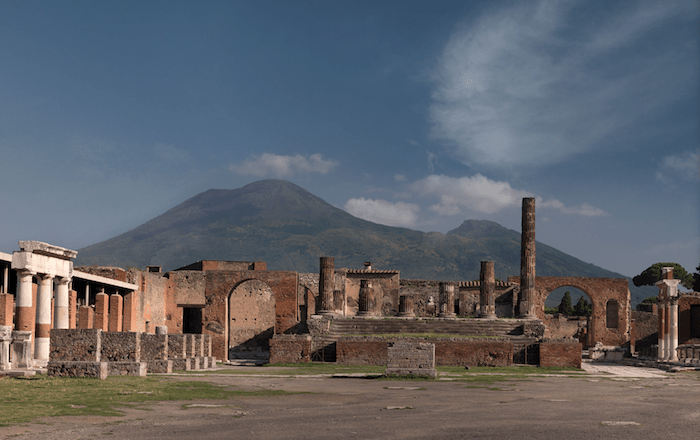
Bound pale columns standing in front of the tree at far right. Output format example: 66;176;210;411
656;267;680;362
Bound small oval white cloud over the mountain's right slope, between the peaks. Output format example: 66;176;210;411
345;198;420;227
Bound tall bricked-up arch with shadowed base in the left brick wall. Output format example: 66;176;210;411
226;278;276;361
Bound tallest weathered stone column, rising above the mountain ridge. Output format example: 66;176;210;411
520;197;537;319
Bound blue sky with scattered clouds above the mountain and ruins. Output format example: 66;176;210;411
0;0;700;276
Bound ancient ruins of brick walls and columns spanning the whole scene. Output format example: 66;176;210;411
0;198;700;377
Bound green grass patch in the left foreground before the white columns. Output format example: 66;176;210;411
0;375;289;426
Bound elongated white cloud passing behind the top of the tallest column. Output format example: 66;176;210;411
409;174;608;217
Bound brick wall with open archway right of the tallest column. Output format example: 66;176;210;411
533;276;630;346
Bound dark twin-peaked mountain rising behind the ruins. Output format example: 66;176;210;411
75;180;655;303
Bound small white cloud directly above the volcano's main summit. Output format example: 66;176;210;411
229;153;338;177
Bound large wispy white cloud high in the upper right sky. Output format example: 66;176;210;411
430;0;698;166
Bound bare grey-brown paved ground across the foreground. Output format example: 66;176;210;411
0;364;700;440
